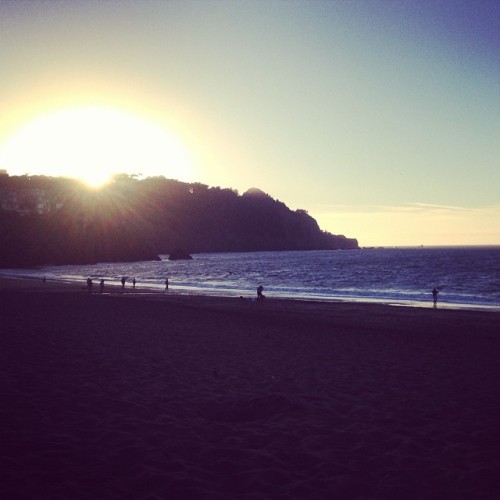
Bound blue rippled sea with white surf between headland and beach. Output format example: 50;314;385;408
0;247;500;312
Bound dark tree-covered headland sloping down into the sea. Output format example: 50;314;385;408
0;174;359;268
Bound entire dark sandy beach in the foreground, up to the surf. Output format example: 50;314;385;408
0;280;500;500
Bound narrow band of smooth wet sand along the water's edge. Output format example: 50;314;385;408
0;277;500;338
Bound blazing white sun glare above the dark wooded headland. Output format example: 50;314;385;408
0;106;193;186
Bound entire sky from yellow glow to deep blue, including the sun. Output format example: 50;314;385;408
0;0;500;246
